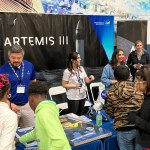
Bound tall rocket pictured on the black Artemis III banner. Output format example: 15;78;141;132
76;20;84;66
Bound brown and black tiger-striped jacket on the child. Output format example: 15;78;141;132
106;81;144;128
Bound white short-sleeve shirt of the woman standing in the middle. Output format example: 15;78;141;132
62;67;87;100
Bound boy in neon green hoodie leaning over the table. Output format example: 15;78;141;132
16;81;71;150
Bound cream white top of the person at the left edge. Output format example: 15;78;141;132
0;102;18;150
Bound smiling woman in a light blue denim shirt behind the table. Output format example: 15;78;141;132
101;49;125;90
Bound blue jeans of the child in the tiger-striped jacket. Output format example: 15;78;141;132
117;129;144;150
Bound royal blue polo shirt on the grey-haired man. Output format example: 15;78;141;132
0;60;36;105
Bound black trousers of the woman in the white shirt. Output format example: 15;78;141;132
67;99;85;116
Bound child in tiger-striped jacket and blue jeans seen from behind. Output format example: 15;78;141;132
105;65;144;150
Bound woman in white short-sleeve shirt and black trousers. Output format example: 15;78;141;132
62;52;94;115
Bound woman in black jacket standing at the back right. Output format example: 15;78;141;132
127;40;150;80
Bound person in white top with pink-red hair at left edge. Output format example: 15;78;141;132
0;74;18;150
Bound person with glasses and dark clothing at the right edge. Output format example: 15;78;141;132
128;65;150;148
